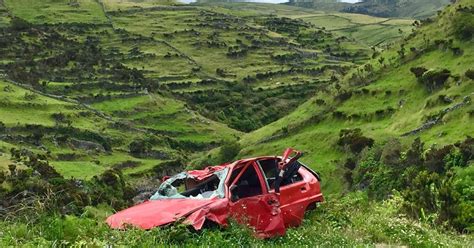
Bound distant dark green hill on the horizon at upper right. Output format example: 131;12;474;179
289;0;453;19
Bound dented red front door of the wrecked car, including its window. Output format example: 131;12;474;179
229;162;285;238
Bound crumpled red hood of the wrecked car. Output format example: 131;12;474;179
106;199;215;229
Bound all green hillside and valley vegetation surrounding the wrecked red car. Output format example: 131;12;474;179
0;0;474;247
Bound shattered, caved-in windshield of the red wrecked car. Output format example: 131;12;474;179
150;168;229;200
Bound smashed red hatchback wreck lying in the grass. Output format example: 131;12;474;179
107;148;323;238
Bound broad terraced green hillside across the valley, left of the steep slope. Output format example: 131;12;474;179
0;0;392;178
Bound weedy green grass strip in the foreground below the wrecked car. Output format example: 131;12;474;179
0;192;473;247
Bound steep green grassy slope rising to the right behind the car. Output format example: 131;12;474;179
240;1;474;192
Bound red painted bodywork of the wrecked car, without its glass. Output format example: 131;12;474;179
107;148;323;238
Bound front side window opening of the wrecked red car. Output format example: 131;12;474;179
231;164;262;200
